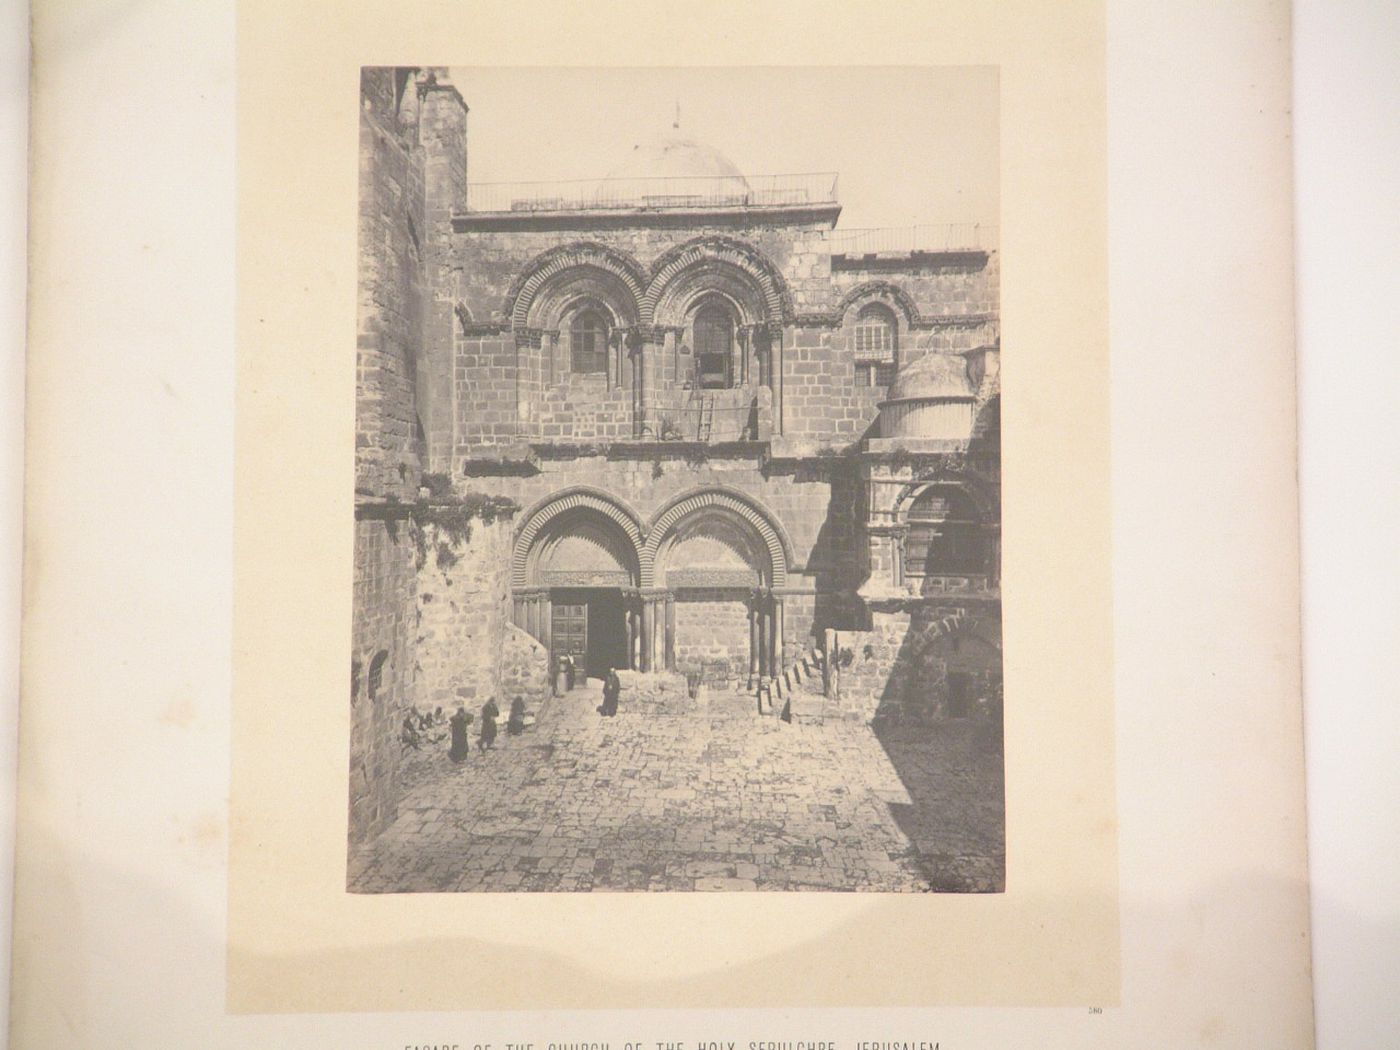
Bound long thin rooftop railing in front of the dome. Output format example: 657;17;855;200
466;171;836;211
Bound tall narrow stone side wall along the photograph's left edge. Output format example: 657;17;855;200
350;69;426;840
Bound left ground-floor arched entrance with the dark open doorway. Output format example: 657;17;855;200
512;491;641;678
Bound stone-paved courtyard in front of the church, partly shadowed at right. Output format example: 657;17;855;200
349;683;1005;893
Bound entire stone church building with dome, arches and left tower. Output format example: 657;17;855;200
350;69;1001;839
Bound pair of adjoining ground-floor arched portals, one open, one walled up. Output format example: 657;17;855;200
511;489;788;682
